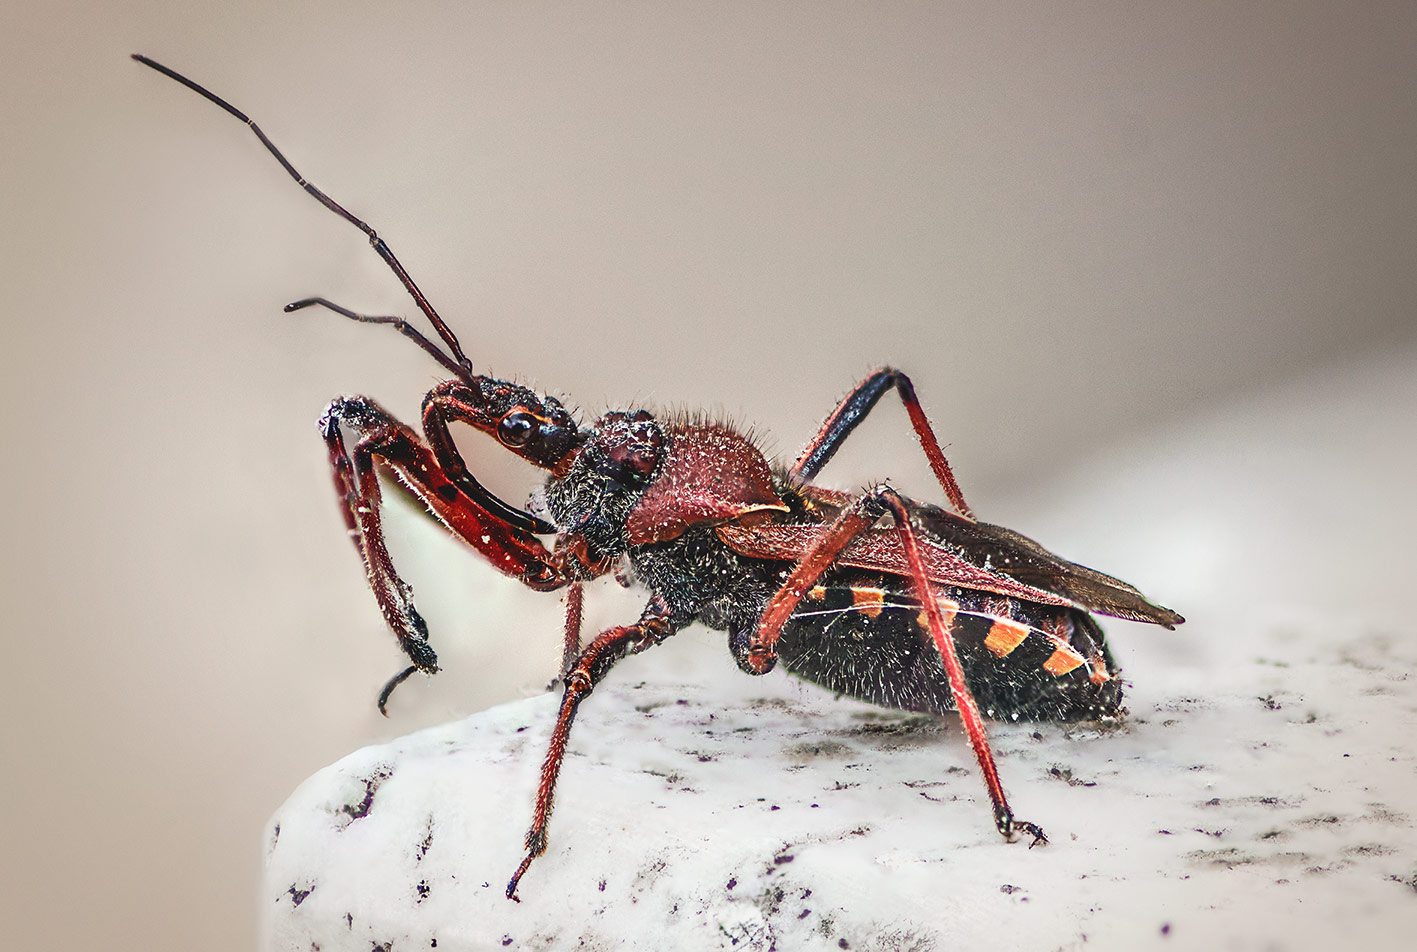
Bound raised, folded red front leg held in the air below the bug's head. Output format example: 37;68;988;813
320;397;570;713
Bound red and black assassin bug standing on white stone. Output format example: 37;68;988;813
133;54;1183;900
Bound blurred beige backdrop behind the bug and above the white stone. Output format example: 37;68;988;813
0;0;1417;949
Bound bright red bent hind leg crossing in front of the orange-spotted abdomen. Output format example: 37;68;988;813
747;487;1047;843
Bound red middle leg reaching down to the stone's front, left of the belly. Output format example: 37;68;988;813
507;598;679;901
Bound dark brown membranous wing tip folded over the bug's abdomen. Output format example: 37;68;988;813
915;506;1186;628
